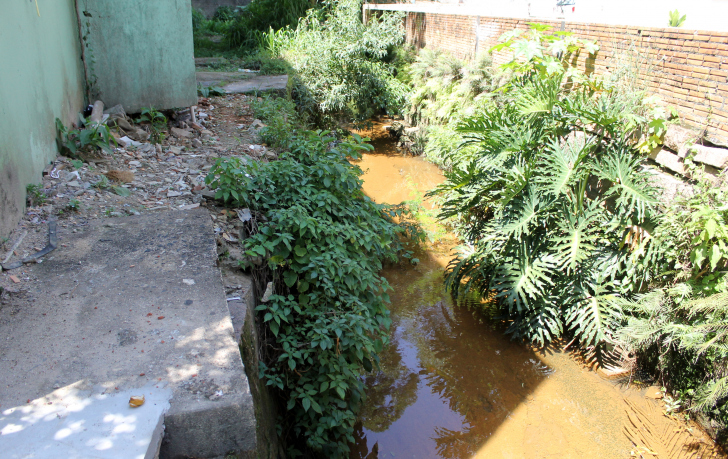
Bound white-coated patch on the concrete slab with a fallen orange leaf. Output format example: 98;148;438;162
0;383;171;459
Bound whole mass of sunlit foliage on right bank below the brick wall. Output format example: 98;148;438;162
410;26;728;435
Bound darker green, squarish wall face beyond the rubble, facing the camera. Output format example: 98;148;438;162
78;0;197;113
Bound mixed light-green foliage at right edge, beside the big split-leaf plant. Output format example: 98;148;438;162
619;172;728;434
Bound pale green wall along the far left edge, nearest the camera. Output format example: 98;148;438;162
0;0;84;237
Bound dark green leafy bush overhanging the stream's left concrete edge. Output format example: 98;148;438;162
207;100;420;457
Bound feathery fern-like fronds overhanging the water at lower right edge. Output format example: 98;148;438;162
619;286;728;440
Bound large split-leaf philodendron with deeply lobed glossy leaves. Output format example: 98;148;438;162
437;26;657;357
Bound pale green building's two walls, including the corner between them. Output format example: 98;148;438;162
0;0;197;237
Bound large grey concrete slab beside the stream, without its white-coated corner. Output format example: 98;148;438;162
0;209;255;457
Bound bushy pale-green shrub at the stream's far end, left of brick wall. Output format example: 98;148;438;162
263;0;408;125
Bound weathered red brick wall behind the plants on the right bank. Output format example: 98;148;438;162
382;8;728;145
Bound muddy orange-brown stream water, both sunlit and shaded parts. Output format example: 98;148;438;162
351;125;724;459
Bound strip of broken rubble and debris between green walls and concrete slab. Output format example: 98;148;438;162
0;95;277;280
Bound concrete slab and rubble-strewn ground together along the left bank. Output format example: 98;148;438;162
0;91;276;457
